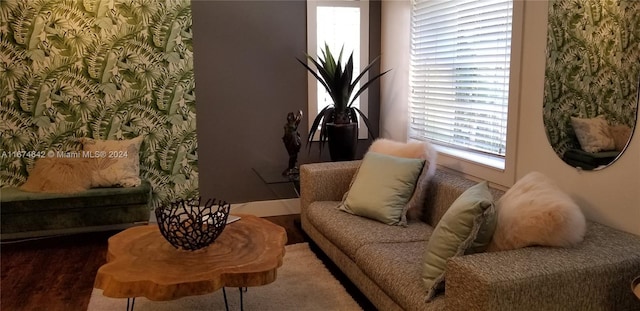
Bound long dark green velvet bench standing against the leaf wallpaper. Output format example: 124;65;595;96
0;181;151;240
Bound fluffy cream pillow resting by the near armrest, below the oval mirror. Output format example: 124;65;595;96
488;172;586;251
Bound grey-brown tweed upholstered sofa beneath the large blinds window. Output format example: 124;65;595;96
300;161;640;310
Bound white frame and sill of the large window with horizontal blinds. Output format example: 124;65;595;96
407;0;524;187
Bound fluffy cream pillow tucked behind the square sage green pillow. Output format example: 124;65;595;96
369;138;438;219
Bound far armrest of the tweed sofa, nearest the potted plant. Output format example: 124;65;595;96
300;160;362;212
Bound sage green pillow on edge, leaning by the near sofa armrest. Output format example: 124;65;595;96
422;181;496;301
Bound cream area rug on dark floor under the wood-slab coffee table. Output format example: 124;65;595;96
87;243;362;311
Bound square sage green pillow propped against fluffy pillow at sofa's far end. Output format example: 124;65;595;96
339;152;425;225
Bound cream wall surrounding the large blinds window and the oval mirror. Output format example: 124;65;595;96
380;0;640;235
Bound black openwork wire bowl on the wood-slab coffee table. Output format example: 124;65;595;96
155;198;231;251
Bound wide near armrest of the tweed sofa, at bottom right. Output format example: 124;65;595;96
445;223;640;310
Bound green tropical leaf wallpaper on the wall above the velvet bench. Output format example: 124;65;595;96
0;0;198;210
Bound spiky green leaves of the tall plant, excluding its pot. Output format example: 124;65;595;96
298;43;389;152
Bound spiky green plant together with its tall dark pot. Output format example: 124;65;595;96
298;43;389;161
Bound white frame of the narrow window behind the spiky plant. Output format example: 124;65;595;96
307;0;369;141
